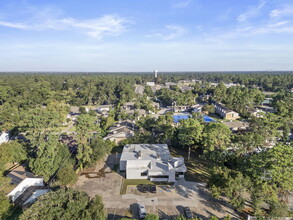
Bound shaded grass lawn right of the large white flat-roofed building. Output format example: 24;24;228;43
170;148;210;183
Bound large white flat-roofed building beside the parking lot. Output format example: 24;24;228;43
120;144;187;182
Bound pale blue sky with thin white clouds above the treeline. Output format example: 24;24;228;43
0;0;293;72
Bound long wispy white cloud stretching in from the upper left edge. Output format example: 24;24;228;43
0;9;130;39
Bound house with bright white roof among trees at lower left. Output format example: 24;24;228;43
6;166;50;208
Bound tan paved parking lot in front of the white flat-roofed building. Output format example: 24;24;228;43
74;156;239;220
